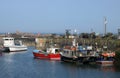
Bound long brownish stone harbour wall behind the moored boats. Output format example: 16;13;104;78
0;38;120;50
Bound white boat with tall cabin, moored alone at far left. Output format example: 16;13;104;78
3;37;27;52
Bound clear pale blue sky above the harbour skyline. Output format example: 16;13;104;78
0;0;120;33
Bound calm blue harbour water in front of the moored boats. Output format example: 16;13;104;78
0;47;120;78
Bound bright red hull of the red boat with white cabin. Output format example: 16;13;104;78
33;52;60;60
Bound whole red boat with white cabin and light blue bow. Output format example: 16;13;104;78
33;48;60;60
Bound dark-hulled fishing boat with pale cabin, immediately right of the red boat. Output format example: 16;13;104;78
61;39;81;63
